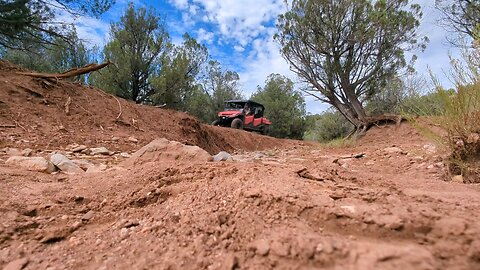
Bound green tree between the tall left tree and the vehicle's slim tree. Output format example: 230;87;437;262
152;34;208;111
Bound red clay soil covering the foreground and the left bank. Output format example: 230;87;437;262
0;61;480;269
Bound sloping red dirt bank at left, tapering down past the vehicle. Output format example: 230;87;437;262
0;61;296;154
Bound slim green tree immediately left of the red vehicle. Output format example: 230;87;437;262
203;60;242;122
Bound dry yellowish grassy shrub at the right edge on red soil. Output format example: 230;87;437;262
437;44;480;183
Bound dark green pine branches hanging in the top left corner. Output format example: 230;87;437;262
0;0;115;50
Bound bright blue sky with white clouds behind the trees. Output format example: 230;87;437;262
65;0;458;113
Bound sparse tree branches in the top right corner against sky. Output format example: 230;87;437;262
435;0;480;44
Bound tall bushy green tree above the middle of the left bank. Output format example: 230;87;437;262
93;3;171;103
